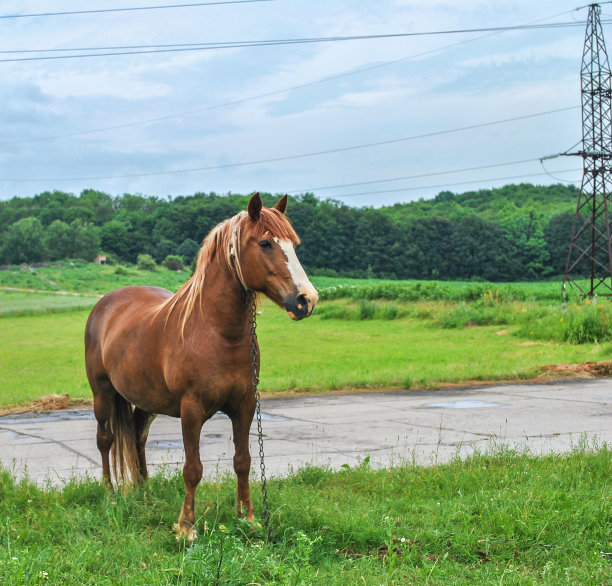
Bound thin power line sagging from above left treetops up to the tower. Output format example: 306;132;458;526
0;106;578;183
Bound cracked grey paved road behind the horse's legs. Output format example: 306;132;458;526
0;380;612;484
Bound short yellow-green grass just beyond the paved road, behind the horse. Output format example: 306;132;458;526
0;302;612;406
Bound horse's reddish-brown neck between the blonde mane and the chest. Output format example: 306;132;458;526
189;260;251;339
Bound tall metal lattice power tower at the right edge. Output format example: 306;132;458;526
563;4;612;297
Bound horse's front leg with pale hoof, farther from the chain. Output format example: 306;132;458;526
174;401;207;541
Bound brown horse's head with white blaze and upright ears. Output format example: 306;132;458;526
236;193;319;320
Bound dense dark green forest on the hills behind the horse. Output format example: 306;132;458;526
0;183;579;281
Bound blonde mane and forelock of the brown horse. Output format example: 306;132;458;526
155;208;300;337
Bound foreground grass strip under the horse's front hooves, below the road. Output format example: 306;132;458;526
0;446;612;585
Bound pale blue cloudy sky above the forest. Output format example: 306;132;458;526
0;0;612;207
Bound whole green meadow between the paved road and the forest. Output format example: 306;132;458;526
0;263;612;407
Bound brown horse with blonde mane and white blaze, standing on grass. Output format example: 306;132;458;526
85;193;318;539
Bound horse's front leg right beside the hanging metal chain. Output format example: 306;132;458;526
231;401;255;522
